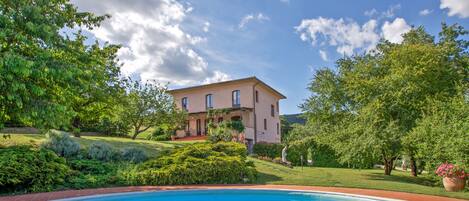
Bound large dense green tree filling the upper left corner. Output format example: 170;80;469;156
0;0;119;128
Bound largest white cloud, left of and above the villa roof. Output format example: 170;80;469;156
73;0;228;85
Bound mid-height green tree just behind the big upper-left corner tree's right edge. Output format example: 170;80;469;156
70;41;125;137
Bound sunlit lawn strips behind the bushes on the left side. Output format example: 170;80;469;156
0;134;192;157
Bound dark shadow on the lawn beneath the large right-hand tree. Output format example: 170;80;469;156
368;173;435;187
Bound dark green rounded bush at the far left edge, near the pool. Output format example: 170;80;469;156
0;146;70;193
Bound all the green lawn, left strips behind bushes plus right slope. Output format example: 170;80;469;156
0;134;469;199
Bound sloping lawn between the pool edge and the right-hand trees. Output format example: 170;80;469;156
254;159;469;199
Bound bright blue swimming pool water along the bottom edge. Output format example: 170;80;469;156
54;189;398;201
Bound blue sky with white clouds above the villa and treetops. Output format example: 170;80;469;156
72;0;469;114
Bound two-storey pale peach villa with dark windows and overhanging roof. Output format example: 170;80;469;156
169;77;286;147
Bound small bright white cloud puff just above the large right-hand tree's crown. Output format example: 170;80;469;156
381;18;411;43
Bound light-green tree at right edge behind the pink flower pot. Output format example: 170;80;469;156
407;95;469;170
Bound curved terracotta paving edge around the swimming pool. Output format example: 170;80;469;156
0;185;462;201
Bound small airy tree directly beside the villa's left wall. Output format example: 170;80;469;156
122;79;185;139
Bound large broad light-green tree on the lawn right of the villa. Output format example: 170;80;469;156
302;25;468;175
